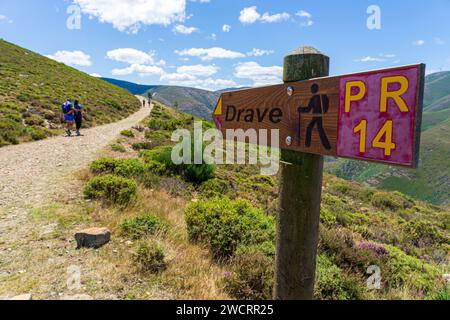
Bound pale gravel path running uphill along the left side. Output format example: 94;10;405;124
0;99;151;300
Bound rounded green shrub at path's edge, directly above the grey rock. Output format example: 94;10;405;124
83;175;137;205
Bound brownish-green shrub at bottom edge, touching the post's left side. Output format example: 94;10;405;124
224;254;274;300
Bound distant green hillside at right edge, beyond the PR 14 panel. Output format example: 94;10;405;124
327;72;450;204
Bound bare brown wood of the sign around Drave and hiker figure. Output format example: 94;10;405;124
222;78;339;156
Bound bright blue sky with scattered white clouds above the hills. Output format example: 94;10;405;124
0;0;450;90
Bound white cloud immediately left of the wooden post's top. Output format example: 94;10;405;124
234;61;283;86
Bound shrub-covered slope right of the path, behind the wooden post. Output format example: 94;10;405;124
60;105;450;300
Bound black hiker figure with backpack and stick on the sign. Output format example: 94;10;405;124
298;84;331;150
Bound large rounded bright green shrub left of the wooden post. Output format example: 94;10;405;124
186;197;275;258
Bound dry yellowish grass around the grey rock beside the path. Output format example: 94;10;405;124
30;170;229;300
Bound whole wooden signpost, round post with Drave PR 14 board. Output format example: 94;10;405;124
213;47;425;300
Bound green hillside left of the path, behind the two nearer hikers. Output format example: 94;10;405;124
0;40;140;146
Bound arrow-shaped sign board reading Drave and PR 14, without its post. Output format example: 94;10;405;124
213;64;425;167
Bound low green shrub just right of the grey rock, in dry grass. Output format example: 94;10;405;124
120;214;168;239
